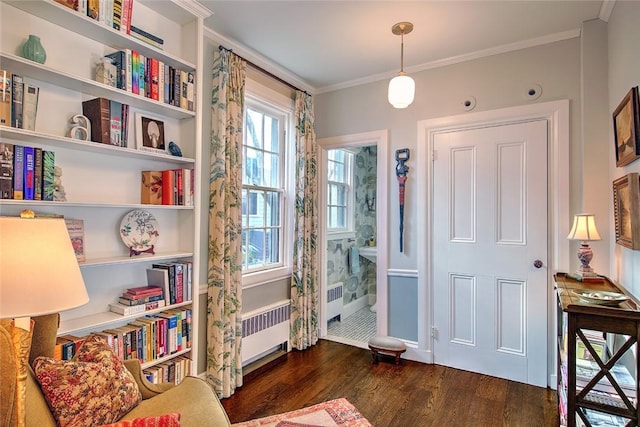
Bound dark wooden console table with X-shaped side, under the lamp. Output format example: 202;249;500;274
554;273;640;427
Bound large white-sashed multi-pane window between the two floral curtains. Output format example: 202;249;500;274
242;92;290;286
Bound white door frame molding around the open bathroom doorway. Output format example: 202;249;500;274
317;129;388;348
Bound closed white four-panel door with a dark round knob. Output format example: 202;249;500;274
433;120;547;387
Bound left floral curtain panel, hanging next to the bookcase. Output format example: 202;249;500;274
206;48;246;398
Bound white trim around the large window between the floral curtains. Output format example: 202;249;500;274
242;79;295;288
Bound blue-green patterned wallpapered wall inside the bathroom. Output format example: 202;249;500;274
327;146;377;304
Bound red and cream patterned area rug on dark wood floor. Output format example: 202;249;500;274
232;398;373;427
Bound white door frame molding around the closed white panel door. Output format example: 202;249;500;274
416;100;570;385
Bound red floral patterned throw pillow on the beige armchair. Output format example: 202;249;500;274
33;335;142;427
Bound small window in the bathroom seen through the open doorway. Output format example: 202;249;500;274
327;149;353;237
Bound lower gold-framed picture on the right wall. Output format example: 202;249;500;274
613;172;640;250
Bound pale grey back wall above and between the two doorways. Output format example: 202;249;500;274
315;38;584;270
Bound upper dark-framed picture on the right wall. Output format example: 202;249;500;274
613;86;640;167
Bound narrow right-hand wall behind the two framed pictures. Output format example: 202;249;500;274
608;1;640;296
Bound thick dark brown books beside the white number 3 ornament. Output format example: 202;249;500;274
82;98;129;147
